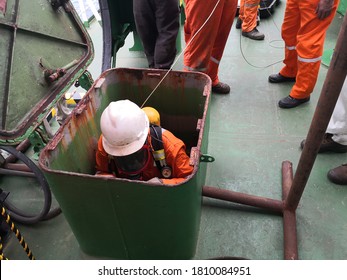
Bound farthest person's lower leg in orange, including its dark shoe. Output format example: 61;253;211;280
242;0;265;40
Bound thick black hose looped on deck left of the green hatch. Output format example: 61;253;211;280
0;146;61;224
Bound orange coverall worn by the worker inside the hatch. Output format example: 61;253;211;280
96;129;194;184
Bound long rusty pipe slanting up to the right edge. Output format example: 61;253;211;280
284;13;347;210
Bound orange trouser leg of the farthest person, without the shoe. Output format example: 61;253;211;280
239;0;260;32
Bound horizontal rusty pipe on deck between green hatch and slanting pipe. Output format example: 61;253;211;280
202;186;283;214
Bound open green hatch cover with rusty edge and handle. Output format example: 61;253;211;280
0;0;94;145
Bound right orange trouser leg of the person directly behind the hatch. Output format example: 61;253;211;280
207;0;237;85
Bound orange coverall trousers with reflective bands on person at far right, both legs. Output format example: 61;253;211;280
280;0;339;99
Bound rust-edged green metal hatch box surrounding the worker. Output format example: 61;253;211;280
39;68;211;259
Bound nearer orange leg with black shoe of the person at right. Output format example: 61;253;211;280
278;0;338;108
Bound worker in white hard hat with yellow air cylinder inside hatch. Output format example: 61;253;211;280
96;100;193;185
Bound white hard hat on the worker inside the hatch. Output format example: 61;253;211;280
100;100;149;156
